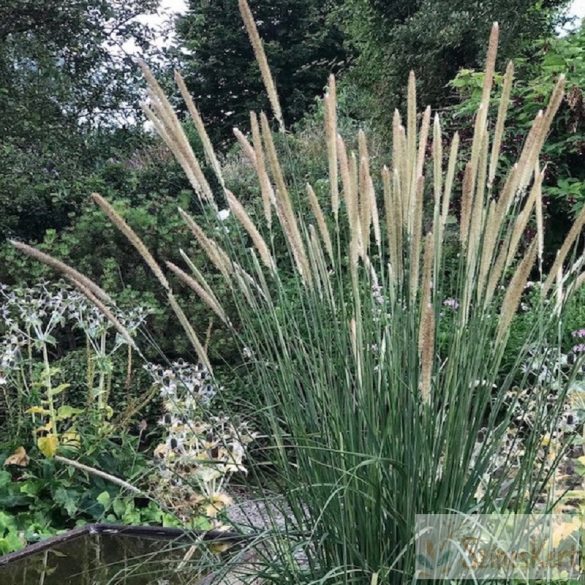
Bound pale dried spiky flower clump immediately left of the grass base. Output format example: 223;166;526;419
145;360;253;518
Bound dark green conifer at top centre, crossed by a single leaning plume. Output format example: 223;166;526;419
177;0;346;143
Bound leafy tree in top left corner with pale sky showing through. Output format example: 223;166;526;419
0;0;158;238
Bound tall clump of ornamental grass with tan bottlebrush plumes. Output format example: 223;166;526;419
13;0;585;583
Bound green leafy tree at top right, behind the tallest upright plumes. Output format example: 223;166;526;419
343;0;567;123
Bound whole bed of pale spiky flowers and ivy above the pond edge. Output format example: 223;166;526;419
0;281;251;554
